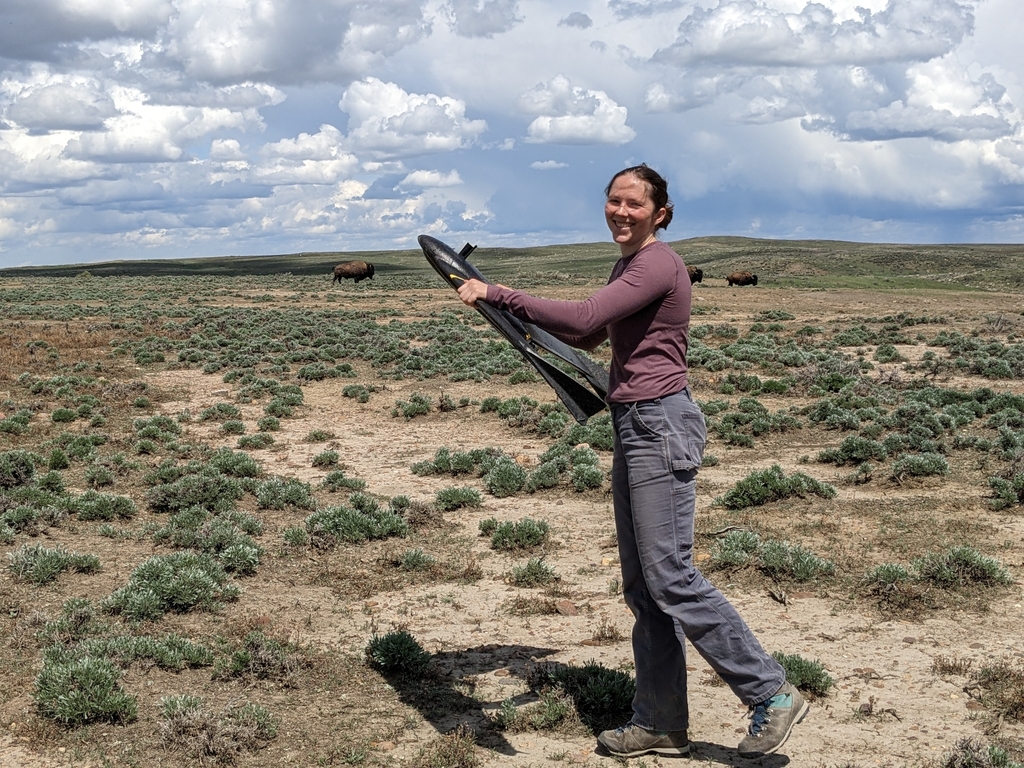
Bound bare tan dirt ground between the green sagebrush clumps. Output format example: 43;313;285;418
0;284;1024;768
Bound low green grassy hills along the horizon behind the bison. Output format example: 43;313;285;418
0;238;1024;290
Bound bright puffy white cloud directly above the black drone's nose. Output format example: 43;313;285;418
338;78;487;160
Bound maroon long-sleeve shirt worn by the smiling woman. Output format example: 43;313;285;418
486;241;690;402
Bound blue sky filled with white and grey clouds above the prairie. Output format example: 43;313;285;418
0;0;1024;267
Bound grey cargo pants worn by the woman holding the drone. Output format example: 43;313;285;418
611;388;785;731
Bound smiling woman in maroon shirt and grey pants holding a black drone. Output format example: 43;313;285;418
459;165;808;758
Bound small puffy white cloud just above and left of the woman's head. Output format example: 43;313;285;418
518;75;636;144
